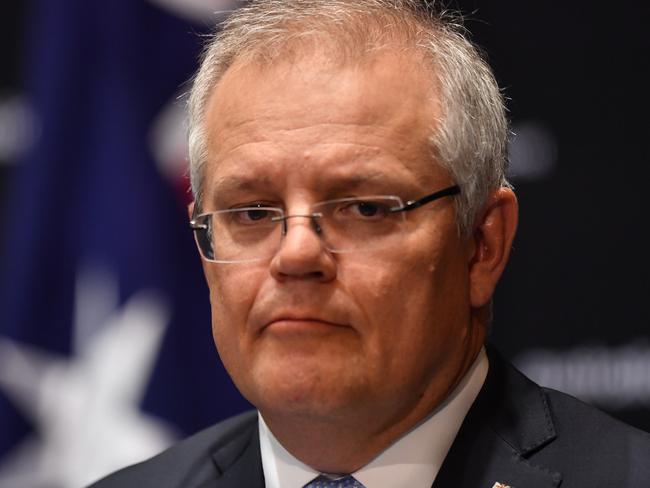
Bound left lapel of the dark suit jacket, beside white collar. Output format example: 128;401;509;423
198;421;264;488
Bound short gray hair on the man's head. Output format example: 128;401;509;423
188;0;509;233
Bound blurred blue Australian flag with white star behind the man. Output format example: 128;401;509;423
0;0;247;488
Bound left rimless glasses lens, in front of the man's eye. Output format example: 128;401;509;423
195;207;282;263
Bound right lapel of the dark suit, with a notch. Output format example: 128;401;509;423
433;349;562;488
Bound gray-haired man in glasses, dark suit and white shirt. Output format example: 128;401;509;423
90;0;650;488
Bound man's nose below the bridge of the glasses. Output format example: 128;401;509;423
270;215;336;282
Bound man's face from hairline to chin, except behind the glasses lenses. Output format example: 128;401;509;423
201;47;480;422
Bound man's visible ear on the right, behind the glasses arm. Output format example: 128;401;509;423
469;188;519;308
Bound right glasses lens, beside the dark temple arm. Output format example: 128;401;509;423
314;197;404;252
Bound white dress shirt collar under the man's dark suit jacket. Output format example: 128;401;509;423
259;349;488;488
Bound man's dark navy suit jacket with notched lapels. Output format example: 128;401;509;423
93;351;650;488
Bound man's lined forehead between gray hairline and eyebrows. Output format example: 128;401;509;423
204;50;440;196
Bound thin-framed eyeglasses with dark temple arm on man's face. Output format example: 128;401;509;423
190;186;460;263
